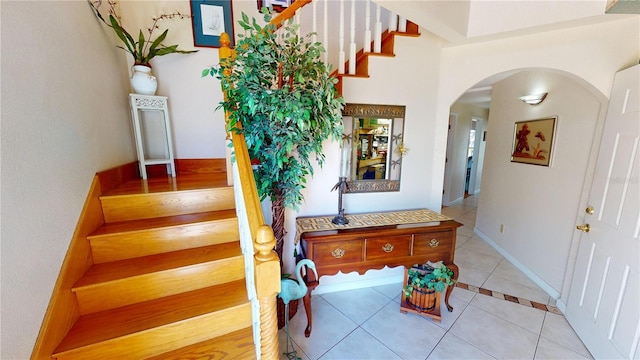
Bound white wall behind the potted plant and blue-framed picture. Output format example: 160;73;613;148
117;0;262;159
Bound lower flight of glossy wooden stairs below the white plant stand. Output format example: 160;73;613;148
52;173;256;360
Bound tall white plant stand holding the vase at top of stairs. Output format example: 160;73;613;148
129;94;176;179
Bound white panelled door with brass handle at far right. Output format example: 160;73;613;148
565;65;640;359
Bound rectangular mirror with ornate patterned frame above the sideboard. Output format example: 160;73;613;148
342;104;405;193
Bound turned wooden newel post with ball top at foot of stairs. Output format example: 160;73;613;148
254;225;280;359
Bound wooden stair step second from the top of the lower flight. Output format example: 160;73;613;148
87;210;240;264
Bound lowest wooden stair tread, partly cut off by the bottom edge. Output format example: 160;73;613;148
146;327;256;360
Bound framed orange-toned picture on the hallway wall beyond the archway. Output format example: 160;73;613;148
511;116;558;166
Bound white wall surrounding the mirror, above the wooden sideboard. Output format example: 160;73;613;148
285;29;441;278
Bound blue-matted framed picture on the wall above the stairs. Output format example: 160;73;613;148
191;0;235;48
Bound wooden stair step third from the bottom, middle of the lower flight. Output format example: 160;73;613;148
72;242;244;314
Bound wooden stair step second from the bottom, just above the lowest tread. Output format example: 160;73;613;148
53;280;252;360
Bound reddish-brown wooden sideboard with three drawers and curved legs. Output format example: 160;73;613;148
300;220;462;337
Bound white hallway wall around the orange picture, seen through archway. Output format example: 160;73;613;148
476;70;606;293
